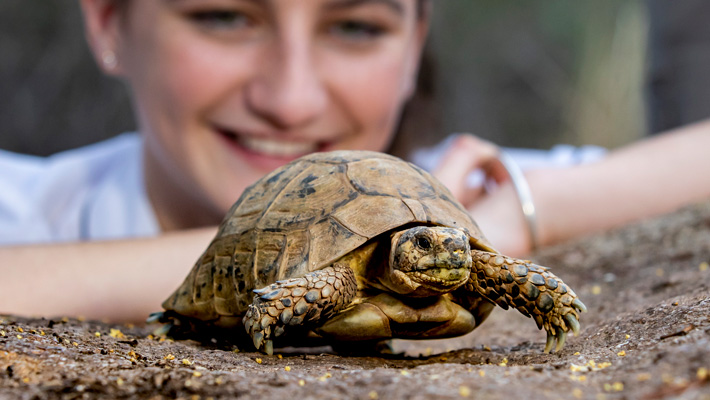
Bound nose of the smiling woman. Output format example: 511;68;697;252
246;42;328;130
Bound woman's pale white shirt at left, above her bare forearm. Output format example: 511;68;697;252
0;133;160;245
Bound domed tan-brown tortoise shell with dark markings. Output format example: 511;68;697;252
163;151;495;326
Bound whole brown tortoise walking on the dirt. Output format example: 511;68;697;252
149;151;586;354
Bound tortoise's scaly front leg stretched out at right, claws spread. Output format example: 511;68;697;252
464;250;587;353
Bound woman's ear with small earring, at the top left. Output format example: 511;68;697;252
80;0;123;76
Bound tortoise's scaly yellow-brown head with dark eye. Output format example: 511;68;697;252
380;226;471;297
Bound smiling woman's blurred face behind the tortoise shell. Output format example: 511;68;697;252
87;0;426;228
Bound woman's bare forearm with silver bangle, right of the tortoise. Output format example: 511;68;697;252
436;120;710;256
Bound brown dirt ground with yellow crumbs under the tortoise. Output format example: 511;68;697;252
0;202;710;399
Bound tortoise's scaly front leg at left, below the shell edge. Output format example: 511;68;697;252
244;263;357;355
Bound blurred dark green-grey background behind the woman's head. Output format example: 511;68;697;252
0;0;710;155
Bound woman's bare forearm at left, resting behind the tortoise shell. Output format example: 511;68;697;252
0;228;216;322
